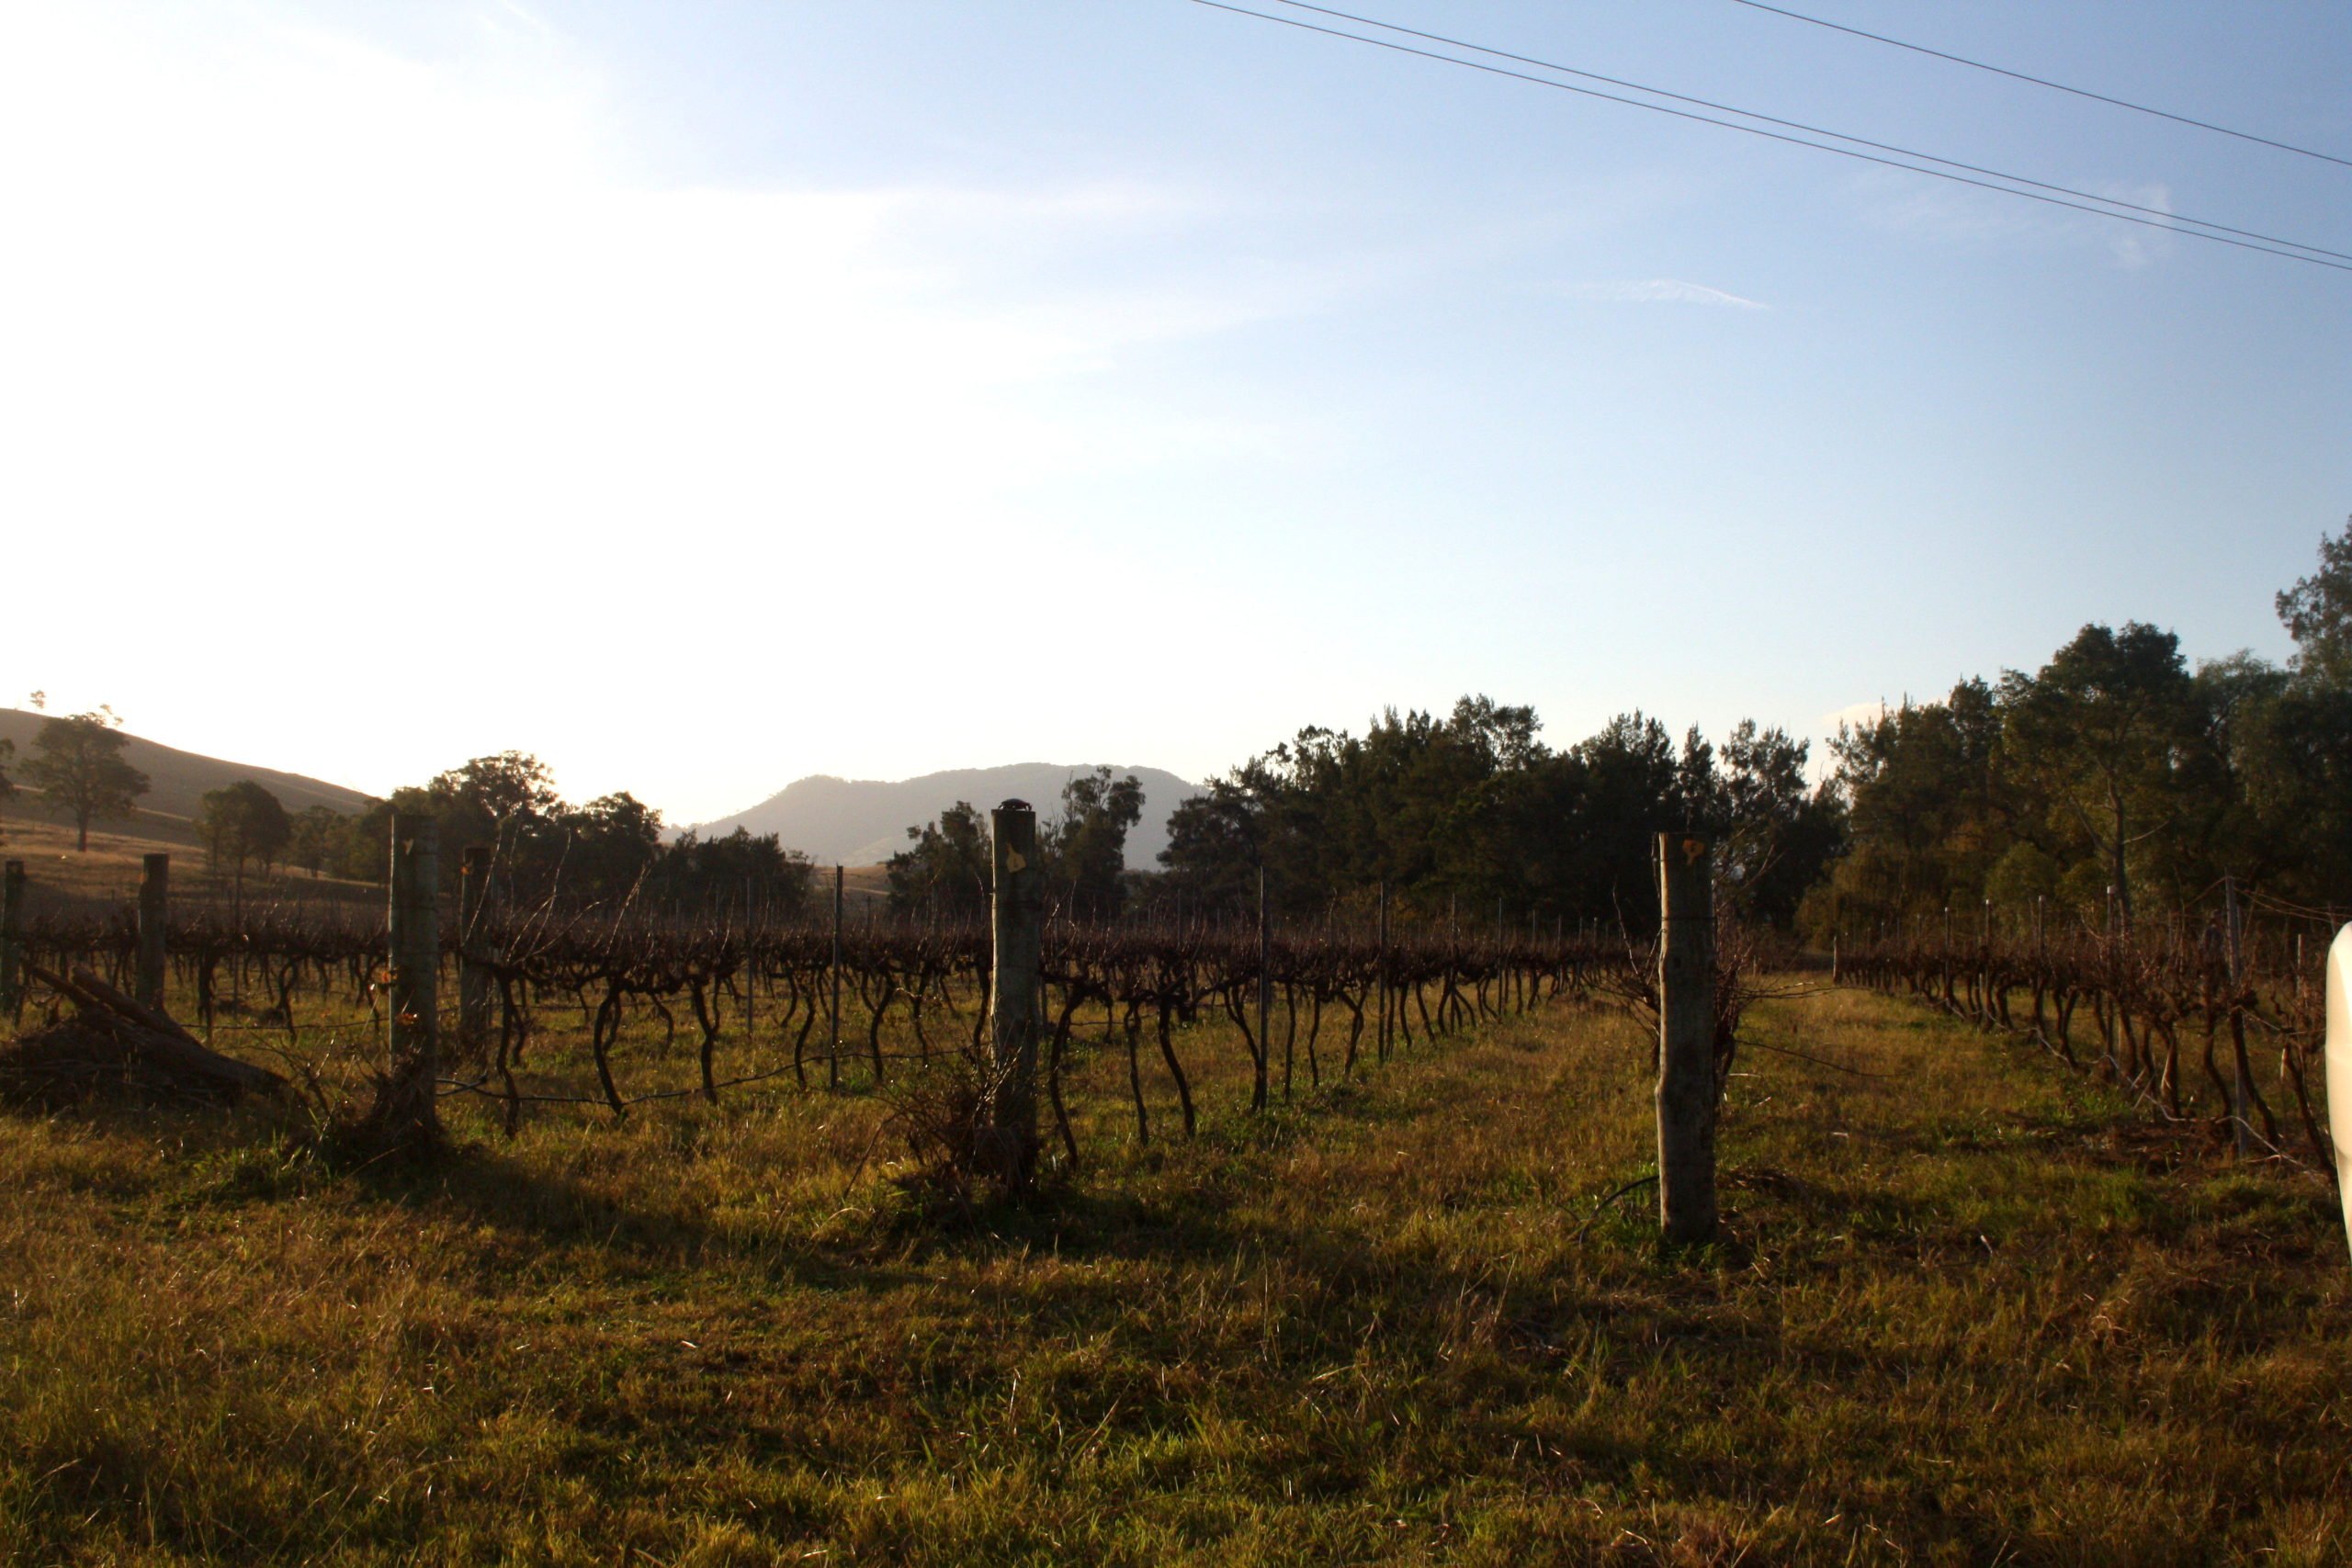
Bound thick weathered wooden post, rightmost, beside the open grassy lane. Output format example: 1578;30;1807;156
1658;832;1714;1244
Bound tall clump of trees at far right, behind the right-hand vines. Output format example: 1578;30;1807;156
1806;522;2352;931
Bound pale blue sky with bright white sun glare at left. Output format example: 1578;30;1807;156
0;0;2352;820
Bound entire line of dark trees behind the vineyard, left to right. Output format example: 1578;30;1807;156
22;520;2352;941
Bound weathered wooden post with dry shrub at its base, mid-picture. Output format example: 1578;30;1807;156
978;799;1045;1192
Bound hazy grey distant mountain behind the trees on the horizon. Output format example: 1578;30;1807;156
694;761;1200;870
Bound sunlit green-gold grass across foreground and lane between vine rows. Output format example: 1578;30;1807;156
0;973;2352;1565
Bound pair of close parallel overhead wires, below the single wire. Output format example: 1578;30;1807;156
1193;0;2352;270
